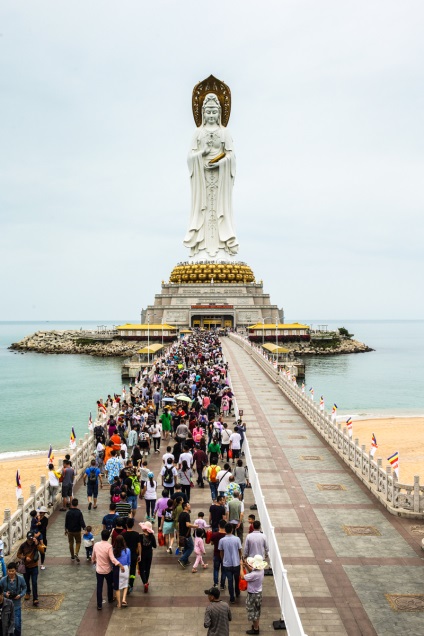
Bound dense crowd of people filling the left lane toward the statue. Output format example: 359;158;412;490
4;331;268;636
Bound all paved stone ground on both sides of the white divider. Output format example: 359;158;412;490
19;338;424;636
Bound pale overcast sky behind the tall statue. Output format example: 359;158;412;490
0;0;424;321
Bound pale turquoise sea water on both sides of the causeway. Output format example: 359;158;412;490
0;319;424;458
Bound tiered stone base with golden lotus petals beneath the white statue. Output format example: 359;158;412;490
143;261;284;329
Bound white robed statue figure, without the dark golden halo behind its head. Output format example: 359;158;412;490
184;93;238;261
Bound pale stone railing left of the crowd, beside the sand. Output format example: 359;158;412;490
0;432;95;557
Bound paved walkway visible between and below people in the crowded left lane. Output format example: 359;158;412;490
23;428;280;636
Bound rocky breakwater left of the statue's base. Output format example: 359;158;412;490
9;330;146;357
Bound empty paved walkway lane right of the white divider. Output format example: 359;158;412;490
222;338;424;636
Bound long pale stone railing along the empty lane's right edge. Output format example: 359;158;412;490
230;333;424;519
